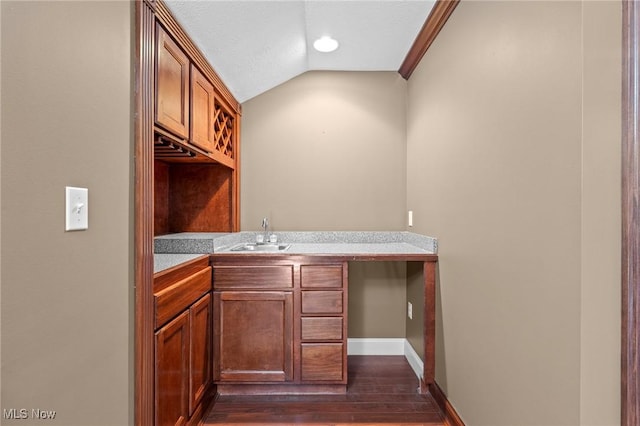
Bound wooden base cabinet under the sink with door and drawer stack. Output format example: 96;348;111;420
212;255;347;393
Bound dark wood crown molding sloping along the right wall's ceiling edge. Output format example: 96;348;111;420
398;0;460;80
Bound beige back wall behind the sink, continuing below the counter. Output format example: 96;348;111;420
241;72;406;337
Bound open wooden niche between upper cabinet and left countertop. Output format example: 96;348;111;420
154;160;236;235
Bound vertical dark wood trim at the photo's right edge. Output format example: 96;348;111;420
621;0;640;426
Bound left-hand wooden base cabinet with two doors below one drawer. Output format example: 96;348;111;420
154;256;213;426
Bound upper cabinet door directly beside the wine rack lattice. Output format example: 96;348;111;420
191;65;215;152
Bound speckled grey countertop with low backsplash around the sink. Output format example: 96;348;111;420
154;231;438;272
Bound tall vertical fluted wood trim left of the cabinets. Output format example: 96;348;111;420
134;1;155;425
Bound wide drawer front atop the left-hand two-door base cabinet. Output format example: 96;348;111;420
153;266;211;328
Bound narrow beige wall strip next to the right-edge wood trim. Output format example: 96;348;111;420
580;1;622;426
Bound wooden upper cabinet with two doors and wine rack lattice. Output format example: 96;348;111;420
154;19;240;170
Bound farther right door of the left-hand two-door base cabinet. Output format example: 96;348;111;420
189;294;213;415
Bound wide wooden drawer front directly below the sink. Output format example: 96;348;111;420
213;265;293;289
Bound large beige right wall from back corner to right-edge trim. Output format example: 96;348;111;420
407;1;620;426
